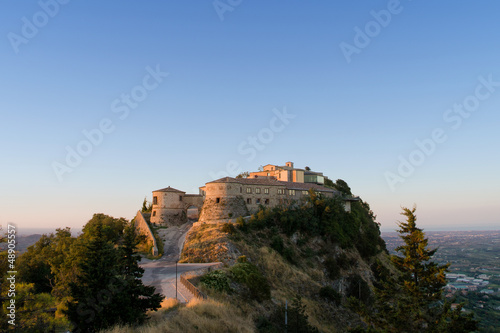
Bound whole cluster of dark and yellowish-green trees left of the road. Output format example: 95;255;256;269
4;214;164;332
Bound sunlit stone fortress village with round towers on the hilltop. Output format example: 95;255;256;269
151;162;359;225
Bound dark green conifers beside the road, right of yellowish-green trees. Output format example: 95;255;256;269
65;216;164;332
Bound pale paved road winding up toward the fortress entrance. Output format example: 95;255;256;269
140;222;218;302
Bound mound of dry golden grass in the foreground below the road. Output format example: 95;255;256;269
102;299;255;333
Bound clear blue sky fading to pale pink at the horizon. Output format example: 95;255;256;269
0;0;500;230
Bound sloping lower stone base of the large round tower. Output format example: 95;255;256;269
199;196;250;221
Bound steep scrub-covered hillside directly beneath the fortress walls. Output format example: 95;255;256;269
184;185;388;332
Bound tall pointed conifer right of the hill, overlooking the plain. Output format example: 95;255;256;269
368;207;478;332
